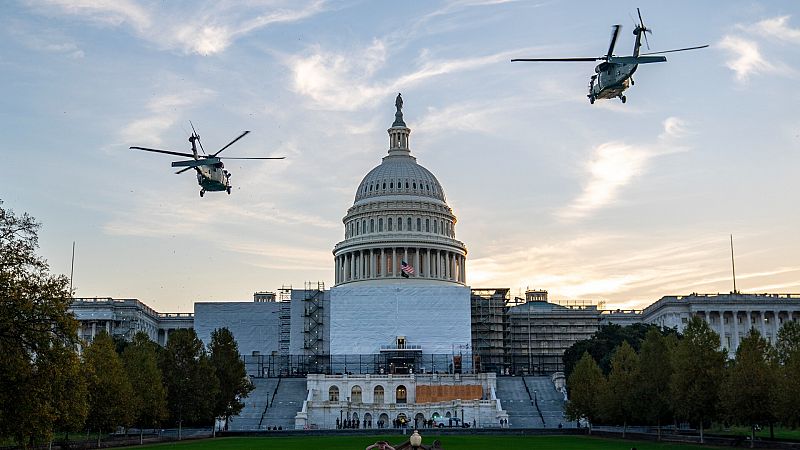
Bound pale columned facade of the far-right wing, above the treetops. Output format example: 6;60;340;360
695;308;800;353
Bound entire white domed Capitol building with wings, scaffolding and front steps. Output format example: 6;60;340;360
72;95;800;429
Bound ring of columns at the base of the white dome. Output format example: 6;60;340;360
336;247;466;284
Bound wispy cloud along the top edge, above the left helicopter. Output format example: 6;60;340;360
31;0;325;56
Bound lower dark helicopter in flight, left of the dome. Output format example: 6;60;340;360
130;125;285;197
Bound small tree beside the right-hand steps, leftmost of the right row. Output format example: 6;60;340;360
566;352;606;433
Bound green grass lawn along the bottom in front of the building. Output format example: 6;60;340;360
136;435;708;450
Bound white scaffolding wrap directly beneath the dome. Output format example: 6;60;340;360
330;283;471;355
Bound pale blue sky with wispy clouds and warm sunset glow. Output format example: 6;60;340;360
0;0;800;312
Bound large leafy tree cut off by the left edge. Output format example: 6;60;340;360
0;201;85;446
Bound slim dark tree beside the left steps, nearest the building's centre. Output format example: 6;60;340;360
209;328;255;430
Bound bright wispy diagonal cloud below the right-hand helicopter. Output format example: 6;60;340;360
556;117;687;220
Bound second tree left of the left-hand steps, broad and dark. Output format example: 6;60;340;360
161;329;219;437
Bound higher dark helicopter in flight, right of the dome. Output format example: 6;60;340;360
511;8;708;104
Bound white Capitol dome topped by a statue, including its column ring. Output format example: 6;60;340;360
333;95;467;285
